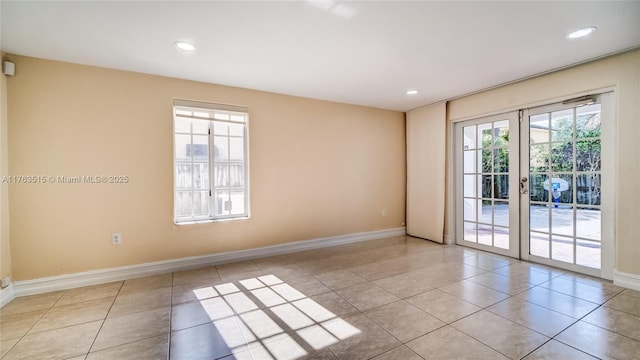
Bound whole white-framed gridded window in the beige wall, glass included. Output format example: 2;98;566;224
173;100;249;224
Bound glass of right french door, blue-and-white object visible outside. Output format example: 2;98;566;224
521;103;602;269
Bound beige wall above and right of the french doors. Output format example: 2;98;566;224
448;50;640;275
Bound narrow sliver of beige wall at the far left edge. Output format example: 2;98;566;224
0;53;11;278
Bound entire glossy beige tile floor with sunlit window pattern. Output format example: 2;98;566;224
0;236;640;360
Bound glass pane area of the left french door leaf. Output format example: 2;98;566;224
457;114;518;256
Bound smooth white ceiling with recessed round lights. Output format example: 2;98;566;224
0;0;640;111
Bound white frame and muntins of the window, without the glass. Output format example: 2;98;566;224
173;99;250;225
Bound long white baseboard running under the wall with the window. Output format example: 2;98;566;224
0;227;407;307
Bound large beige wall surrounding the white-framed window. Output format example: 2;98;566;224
7;55;405;280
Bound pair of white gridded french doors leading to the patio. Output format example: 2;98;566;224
455;94;614;278
